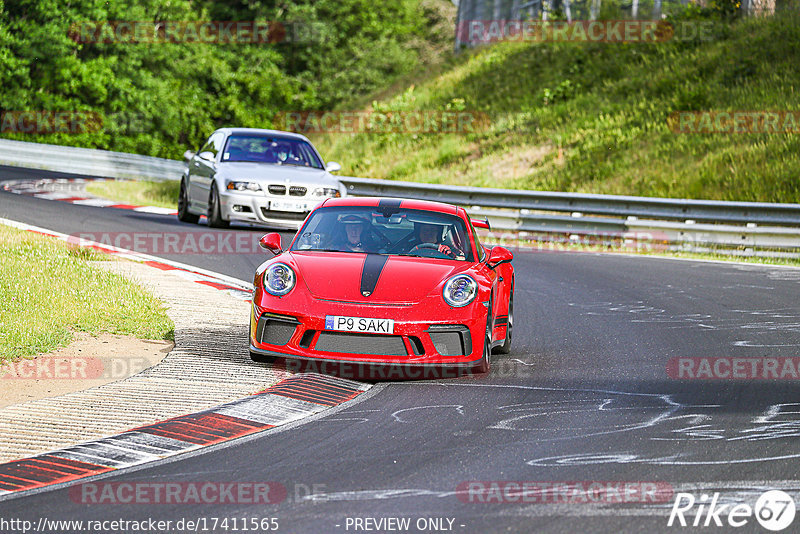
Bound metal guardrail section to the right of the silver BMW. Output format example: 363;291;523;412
340;177;800;258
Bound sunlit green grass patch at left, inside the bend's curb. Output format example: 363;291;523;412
0;225;174;361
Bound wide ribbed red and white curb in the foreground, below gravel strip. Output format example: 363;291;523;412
0;373;371;499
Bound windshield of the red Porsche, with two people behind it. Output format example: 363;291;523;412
292;206;475;261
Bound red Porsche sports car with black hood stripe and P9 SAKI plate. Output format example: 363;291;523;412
250;198;514;378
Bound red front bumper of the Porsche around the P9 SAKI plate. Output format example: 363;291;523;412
250;291;488;369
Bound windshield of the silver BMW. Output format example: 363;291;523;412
222;135;322;169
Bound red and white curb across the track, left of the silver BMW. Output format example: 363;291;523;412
3;178;178;215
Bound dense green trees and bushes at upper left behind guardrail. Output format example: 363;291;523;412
0;0;453;159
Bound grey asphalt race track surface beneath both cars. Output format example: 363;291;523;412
0;168;800;533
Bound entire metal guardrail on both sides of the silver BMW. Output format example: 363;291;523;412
0;139;800;257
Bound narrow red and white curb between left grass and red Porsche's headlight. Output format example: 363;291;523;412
0;218;253;300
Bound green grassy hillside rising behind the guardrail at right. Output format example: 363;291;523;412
312;13;800;203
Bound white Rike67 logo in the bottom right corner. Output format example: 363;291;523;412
667;490;795;532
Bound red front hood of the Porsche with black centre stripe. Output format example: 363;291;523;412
292;252;470;304
